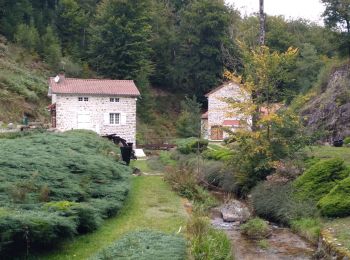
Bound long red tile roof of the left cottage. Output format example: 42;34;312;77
49;78;140;96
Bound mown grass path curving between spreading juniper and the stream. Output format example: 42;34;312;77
32;176;187;260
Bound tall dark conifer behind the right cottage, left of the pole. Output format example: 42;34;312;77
174;0;237;95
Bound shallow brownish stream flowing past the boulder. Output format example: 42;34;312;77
211;200;316;260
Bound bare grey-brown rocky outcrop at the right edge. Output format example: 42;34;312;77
301;64;350;141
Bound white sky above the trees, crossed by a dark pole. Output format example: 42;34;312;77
225;0;325;24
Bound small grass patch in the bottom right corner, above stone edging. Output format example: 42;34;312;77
325;217;350;250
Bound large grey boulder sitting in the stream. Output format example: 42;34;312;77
220;200;251;223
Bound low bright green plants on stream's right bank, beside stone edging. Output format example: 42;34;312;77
290;218;322;244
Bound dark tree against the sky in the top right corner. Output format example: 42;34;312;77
321;0;350;56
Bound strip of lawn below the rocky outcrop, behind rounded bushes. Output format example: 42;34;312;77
306;146;350;166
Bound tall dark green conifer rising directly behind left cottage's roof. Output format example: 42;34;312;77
90;0;152;82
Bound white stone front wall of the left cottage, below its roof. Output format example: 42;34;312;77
56;94;136;144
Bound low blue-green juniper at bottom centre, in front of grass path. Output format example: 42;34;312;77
91;231;186;260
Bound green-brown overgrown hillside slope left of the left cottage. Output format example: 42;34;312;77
0;36;52;123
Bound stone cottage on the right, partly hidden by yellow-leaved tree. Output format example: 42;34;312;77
201;82;251;141
